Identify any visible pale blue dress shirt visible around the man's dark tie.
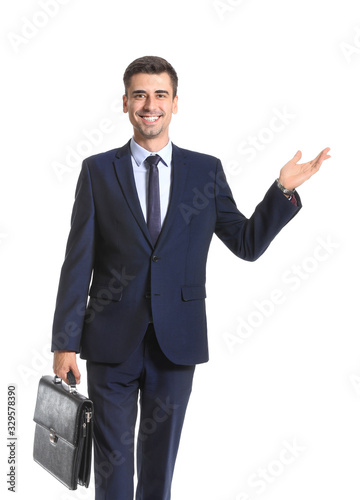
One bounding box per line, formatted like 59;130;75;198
130;137;172;229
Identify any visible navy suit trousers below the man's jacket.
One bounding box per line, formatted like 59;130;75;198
87;324;195;500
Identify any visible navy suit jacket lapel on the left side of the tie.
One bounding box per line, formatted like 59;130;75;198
114;141;152;246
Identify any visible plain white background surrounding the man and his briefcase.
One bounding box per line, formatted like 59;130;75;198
0;0;360;500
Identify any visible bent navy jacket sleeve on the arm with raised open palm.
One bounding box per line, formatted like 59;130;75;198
215;160;302;261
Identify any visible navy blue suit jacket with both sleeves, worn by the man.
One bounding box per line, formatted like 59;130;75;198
52;143;301;365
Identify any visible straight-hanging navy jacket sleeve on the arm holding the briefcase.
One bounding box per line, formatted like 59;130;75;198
51;160;95;352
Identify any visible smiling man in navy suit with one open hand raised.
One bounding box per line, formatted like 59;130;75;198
52;57;330;500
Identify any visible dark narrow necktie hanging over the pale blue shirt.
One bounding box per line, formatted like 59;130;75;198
146;155;161;246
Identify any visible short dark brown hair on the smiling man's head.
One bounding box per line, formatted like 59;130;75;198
124;56;178;97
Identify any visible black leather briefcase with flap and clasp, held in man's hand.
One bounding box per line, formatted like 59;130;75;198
33;372;94;490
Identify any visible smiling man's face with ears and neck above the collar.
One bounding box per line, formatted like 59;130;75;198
123;73;178;147
